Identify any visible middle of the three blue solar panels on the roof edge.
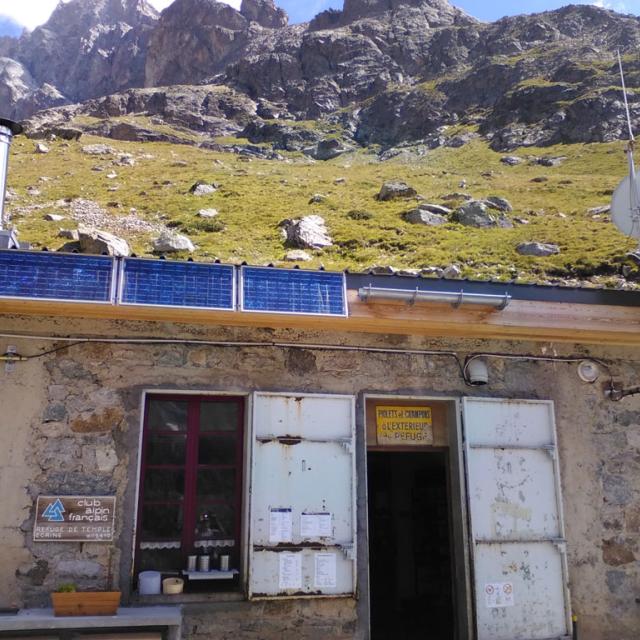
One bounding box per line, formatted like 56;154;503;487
118;258;235;311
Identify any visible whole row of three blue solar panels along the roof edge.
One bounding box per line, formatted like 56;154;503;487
0;250;347;316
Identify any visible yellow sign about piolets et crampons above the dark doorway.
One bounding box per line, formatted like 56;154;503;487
376;406;433;446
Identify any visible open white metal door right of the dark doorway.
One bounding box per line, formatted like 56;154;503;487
463;398;571;640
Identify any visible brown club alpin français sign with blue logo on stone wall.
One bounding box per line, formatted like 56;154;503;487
33;496;116;542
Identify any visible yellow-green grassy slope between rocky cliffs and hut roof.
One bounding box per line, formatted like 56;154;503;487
9;122;635;285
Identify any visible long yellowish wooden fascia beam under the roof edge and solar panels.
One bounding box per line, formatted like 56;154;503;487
0;291;640;346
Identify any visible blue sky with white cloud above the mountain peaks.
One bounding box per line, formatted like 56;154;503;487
0;0;640;29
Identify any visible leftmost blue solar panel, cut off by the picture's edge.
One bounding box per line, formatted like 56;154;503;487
0;249;114;303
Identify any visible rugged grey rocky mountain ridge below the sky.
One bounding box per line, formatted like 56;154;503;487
0;0;640;155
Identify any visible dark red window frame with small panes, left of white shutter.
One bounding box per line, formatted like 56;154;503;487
134;394;245;576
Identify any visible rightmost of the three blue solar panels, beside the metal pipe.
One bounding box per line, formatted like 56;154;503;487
241;267;347;316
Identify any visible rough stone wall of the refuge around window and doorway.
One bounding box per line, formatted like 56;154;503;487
0;317;640;640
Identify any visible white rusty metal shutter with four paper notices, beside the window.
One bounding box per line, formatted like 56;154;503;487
249;393;356;598
